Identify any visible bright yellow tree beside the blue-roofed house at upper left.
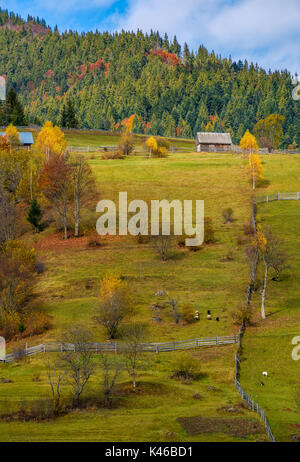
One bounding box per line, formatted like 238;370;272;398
34;121;67;159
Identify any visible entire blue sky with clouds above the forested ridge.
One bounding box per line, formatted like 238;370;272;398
0;0;300;75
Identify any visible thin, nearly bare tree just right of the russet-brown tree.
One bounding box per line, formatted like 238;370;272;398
70;157;95;237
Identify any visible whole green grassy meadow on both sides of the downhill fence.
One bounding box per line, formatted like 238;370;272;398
0;147;300;441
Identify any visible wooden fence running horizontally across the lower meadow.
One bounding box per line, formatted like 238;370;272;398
1;335;238;362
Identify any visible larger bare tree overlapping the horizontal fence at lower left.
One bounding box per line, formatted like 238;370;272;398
62;326;95;406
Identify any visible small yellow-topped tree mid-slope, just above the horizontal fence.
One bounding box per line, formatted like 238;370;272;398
95;275;133;339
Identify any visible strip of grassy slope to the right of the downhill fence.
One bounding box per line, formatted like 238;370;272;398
241;156;300;441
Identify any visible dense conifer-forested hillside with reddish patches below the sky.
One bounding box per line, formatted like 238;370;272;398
0;11;300;146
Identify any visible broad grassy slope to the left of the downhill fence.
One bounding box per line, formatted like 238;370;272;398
0;154;264;441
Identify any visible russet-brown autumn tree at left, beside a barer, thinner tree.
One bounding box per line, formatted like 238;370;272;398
40;154;72;239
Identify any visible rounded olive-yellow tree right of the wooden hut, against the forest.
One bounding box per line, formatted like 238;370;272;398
253;114;285;152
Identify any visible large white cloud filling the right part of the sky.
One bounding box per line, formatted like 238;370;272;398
112;0;300;72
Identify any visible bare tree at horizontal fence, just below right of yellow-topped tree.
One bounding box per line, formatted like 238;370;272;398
122;323;148;390
